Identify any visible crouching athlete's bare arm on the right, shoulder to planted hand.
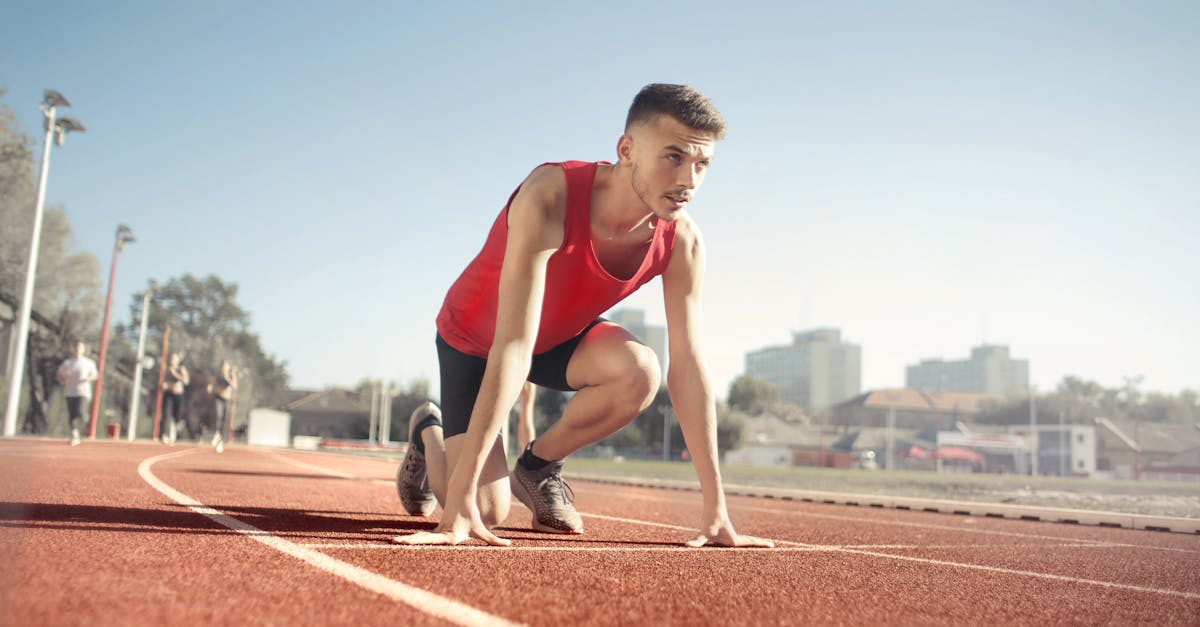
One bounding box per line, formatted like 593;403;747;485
662;215;774;547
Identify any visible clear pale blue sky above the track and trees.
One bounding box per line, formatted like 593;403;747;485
0;0;1200;396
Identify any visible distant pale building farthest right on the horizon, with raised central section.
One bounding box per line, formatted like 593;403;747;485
905;345;1030;394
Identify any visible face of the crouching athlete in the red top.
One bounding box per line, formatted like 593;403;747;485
617;115;716;221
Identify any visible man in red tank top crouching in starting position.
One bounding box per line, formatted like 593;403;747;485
395;84;772;547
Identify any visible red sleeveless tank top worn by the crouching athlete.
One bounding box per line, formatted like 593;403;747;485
438;161;674;357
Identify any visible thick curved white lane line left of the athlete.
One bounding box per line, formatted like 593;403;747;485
138;449;518;626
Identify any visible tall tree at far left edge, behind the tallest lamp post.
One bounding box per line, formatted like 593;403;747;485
0;89;101;434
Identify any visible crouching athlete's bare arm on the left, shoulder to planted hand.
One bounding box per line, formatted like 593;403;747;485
398;166;566;545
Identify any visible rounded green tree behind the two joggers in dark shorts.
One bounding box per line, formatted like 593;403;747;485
119;274;288;432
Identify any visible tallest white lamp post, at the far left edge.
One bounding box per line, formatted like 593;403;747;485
4;89;86;437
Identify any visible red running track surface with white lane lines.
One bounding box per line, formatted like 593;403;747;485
0;440;1200;626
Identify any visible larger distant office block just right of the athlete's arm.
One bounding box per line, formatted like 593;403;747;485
745;329;863;413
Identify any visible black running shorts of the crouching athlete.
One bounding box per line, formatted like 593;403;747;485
437;318;605;437
